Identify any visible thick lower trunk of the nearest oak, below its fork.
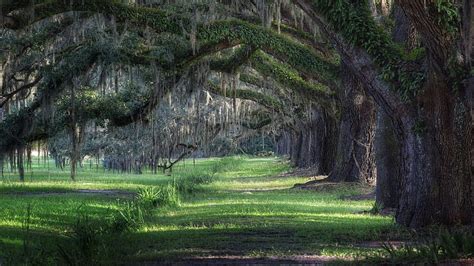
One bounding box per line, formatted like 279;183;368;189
396;75;473;228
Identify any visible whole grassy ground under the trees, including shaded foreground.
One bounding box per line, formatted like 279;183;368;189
0;157;466;265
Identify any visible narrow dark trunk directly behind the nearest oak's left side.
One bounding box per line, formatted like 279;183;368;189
375;108;402;208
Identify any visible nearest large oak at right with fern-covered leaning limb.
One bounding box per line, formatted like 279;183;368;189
297;0;473;227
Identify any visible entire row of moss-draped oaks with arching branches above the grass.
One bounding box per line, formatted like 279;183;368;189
0;0;474;233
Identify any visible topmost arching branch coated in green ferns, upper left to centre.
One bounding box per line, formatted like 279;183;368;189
10;0;338;86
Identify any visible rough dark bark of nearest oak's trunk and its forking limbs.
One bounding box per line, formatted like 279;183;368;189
295;0;473;228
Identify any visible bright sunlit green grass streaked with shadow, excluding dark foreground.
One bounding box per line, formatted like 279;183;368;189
0;158;400;260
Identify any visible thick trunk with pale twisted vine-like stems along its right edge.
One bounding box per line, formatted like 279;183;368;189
327;65;376;184
